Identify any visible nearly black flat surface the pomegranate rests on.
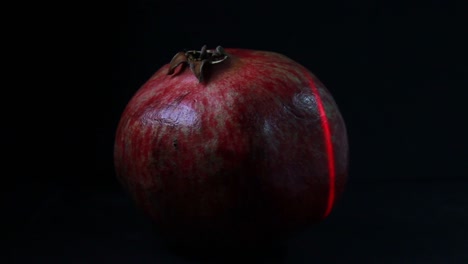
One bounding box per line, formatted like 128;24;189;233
7;178;468;264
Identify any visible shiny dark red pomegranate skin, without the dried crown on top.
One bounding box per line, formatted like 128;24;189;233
114;49;348;249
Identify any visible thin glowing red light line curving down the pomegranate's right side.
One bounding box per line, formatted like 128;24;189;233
307;74;335;218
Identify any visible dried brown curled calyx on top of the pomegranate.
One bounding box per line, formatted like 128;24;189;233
167;45;229;82
